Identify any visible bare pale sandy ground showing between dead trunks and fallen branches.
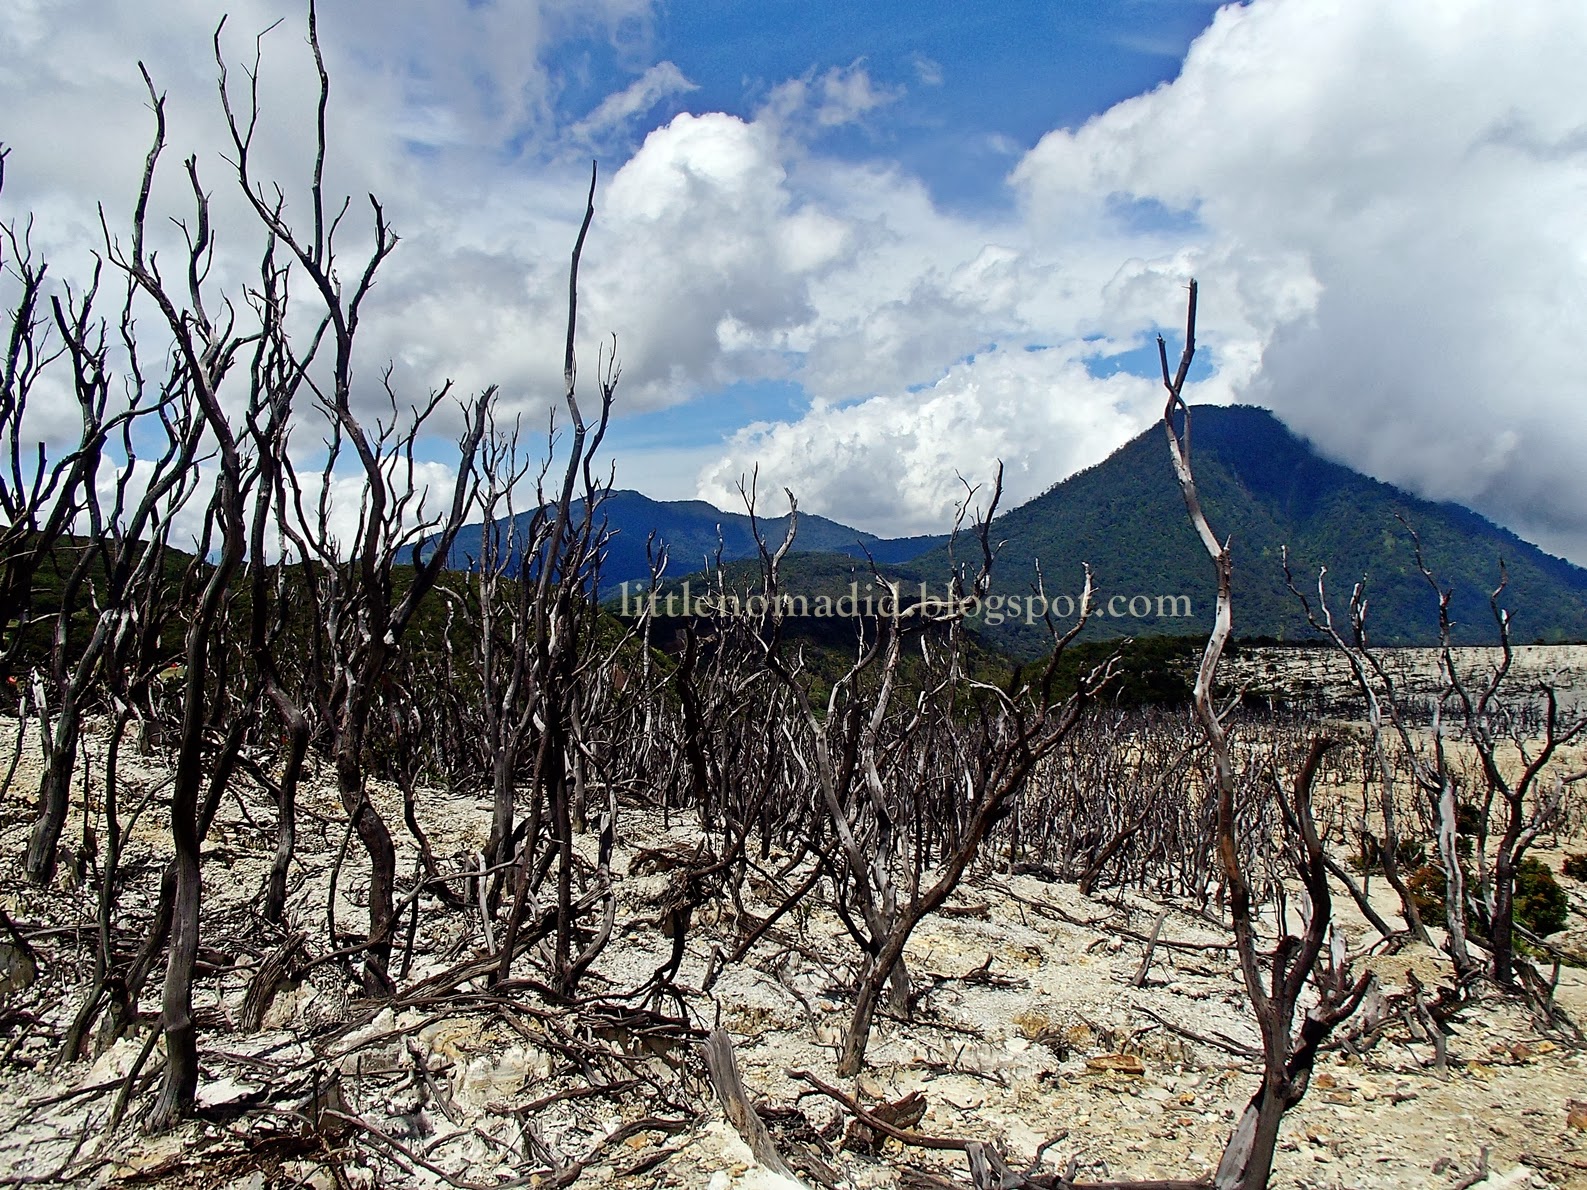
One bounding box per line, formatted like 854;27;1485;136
0;666;1587;1190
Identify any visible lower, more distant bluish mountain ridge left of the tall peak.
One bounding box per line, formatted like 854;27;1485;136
448;490;946;595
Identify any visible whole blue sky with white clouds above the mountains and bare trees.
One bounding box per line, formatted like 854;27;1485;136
0;0;1587;563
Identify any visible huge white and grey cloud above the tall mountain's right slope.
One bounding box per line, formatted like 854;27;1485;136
1014;0;1587;559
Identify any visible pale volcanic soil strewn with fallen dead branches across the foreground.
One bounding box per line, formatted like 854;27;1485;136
0;656;1587;1190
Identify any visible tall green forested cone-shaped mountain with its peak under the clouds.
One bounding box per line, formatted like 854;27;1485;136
908;406;1587;654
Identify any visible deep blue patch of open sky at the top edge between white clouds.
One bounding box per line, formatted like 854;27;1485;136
555;0;1216;209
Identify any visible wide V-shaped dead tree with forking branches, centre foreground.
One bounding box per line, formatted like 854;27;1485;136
746;468;1112;1076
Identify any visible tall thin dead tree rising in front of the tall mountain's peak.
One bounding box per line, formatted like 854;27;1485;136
1157;281;1370;1190
